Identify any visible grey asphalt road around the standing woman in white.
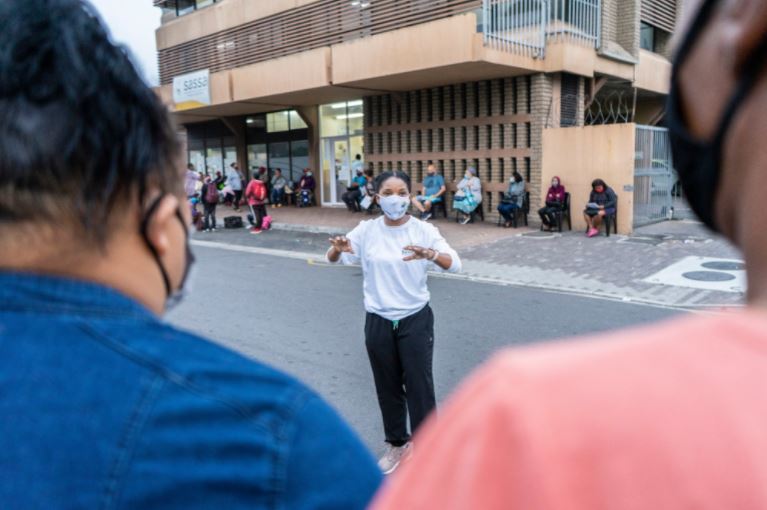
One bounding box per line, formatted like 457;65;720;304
169;243;678;453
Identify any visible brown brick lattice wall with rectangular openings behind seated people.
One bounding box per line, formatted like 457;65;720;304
365;74;551;219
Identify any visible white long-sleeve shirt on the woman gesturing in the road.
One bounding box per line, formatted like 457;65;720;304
326;216;461;321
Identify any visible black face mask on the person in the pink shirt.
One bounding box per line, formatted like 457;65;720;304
667;0;767;232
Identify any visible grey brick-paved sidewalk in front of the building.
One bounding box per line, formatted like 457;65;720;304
208;207;745;313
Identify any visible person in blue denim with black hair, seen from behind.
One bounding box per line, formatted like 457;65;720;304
0;0;382;510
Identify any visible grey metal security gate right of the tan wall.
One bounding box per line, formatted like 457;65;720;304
634;126;676;227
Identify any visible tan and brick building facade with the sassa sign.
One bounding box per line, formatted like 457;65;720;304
155;0;681;227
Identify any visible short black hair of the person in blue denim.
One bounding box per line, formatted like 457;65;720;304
0;0;181;245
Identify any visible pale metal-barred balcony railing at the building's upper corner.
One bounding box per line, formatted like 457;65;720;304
482;0;602;58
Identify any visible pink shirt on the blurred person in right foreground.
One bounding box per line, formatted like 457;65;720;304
373;311;767;510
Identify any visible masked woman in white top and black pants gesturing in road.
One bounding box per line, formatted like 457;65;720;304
327;172;461;474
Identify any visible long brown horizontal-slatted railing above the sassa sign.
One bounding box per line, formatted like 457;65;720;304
159;0;482;84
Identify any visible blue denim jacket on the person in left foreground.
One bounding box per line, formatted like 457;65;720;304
0;272;381;510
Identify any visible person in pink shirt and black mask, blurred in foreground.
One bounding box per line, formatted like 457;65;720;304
372;0;767;510
